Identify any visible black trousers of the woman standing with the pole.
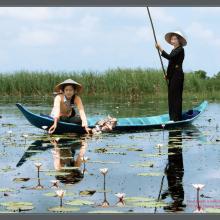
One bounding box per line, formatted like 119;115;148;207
168;72;184;121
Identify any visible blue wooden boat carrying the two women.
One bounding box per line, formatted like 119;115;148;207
16;101;208;134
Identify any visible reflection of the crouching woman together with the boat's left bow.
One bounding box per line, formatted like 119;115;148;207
16;136;87;185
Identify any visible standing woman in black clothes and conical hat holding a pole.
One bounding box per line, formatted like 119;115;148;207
156;31;187;121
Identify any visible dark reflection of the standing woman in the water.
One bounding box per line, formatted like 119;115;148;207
161;130;186;212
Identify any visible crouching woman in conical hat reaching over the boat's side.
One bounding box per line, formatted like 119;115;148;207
49;79;90;134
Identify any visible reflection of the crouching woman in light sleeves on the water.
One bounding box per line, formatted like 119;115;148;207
51;139;87;184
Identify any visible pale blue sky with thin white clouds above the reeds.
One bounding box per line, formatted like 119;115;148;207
0;7;220;76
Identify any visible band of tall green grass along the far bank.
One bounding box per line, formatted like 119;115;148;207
0;68;220;99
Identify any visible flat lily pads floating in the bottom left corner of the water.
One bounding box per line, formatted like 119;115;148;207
0;202;34;212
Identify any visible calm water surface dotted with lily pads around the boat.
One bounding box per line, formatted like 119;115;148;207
0;98;220;213
